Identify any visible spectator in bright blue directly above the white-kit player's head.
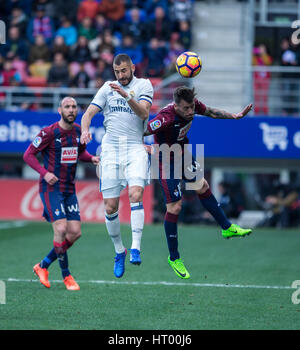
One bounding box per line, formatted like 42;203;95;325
115;35;144;77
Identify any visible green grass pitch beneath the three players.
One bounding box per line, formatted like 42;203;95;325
0;222;300;330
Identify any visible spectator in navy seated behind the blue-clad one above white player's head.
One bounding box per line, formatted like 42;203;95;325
121;7;147;44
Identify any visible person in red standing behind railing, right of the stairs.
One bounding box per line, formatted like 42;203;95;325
252;44;273;115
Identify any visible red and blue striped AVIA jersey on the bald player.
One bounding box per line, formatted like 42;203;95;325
24;122;86;193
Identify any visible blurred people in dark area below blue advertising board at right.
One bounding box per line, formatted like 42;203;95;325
153;171;300;229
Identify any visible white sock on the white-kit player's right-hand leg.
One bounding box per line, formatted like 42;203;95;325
130;202;145;251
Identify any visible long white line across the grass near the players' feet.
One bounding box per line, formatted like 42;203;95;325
0;278;295;289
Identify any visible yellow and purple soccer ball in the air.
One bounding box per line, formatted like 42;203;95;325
176;51;202;78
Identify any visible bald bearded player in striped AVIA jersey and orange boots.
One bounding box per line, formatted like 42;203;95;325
23;97;99;290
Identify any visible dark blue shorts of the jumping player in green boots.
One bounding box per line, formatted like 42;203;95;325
159;157;200;203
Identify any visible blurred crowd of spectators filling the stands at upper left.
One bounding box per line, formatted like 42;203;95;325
0;0;193;88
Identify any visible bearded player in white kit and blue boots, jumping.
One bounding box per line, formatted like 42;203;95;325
81;54;153;278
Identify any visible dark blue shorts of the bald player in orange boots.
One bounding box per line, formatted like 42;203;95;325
40;191;80;222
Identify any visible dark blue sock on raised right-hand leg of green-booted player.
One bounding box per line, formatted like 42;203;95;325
198;189;231;230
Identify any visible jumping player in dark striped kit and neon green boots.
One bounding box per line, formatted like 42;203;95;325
145;86;252;279
